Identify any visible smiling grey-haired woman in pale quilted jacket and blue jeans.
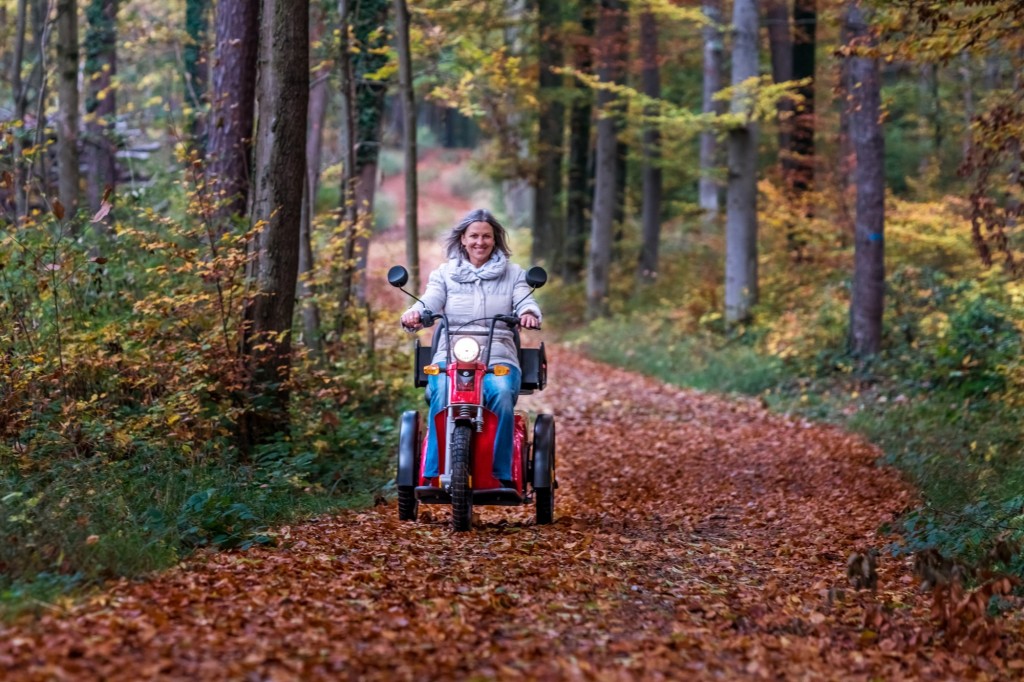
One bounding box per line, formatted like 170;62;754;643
401;209;541;487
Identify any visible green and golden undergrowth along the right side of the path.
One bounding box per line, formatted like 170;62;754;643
561;184;1024;578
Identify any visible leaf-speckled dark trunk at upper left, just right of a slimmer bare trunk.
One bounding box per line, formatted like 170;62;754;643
84;0;118;216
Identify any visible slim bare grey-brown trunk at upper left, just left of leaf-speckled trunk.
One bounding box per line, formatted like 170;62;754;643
56;0;80;219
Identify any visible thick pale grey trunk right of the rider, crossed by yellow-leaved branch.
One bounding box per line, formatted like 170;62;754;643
725;0;758;325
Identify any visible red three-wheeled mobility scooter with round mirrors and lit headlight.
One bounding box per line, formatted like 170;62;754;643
387;265;558;531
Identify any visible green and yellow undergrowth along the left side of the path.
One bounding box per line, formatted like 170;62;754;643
0;160;414;616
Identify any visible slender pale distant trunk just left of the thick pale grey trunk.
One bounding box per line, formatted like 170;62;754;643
697;0;724;231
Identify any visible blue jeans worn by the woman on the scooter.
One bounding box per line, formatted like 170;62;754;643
423;363;522;480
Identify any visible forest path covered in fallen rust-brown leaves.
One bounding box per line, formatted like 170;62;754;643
0;151;1024;680
